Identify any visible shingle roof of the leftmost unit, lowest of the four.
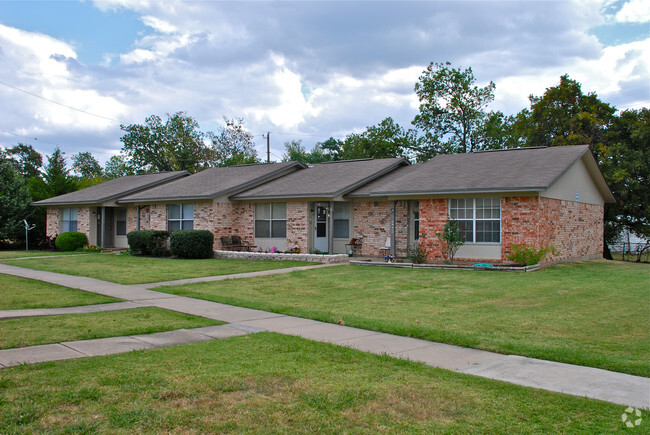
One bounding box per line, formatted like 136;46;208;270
32;171;190;205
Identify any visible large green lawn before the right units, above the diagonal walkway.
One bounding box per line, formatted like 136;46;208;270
158;261;650;377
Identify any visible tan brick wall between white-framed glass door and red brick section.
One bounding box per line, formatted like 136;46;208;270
352;201;408;257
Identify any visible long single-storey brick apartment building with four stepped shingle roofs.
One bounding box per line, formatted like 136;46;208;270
34;145;614;263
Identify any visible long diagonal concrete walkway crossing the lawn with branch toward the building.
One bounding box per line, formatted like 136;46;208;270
0;264;650;409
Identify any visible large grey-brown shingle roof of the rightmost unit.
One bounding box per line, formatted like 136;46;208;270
349;145;608;197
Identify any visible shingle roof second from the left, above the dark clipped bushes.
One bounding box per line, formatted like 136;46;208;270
118;162;305;204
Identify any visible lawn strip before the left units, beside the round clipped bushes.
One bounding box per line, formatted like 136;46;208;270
3;254;313;284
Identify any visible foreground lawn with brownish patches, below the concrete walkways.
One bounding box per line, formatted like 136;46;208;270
0;333;628;434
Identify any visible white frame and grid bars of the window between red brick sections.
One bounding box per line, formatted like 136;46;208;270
448;197;501;245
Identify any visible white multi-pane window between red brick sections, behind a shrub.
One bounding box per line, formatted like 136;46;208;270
449;198;501;243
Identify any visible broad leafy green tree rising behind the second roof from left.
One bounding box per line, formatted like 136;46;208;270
120;112;214;173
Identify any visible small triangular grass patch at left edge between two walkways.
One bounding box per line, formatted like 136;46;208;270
0;274;121;310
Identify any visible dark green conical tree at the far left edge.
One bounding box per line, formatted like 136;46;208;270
0;159;32;241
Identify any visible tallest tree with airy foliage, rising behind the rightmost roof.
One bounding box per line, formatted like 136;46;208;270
413;62;495;156
